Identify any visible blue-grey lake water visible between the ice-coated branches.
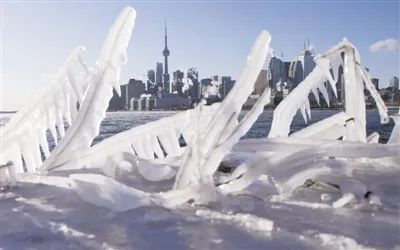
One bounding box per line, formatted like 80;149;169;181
0;110;394;143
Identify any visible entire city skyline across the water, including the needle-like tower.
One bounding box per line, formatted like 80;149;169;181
108;30;400;111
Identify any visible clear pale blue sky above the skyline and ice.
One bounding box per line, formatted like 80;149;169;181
0;0;400;110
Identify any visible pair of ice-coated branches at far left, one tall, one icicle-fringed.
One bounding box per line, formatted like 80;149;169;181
1;7;136;176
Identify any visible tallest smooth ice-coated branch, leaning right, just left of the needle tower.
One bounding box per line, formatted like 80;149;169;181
41;7;136;171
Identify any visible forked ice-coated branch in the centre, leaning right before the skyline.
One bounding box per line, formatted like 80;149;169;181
174;31;271;189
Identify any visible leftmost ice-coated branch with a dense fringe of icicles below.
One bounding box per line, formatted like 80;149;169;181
0;47;91;173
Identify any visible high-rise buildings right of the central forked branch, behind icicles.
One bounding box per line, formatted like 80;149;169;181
252;39;400;108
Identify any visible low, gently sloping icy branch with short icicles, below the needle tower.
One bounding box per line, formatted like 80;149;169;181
60;103;220;169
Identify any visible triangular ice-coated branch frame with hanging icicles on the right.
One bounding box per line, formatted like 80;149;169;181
268;39;389;142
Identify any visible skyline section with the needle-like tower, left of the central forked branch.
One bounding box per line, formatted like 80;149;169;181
108;23;235;111
